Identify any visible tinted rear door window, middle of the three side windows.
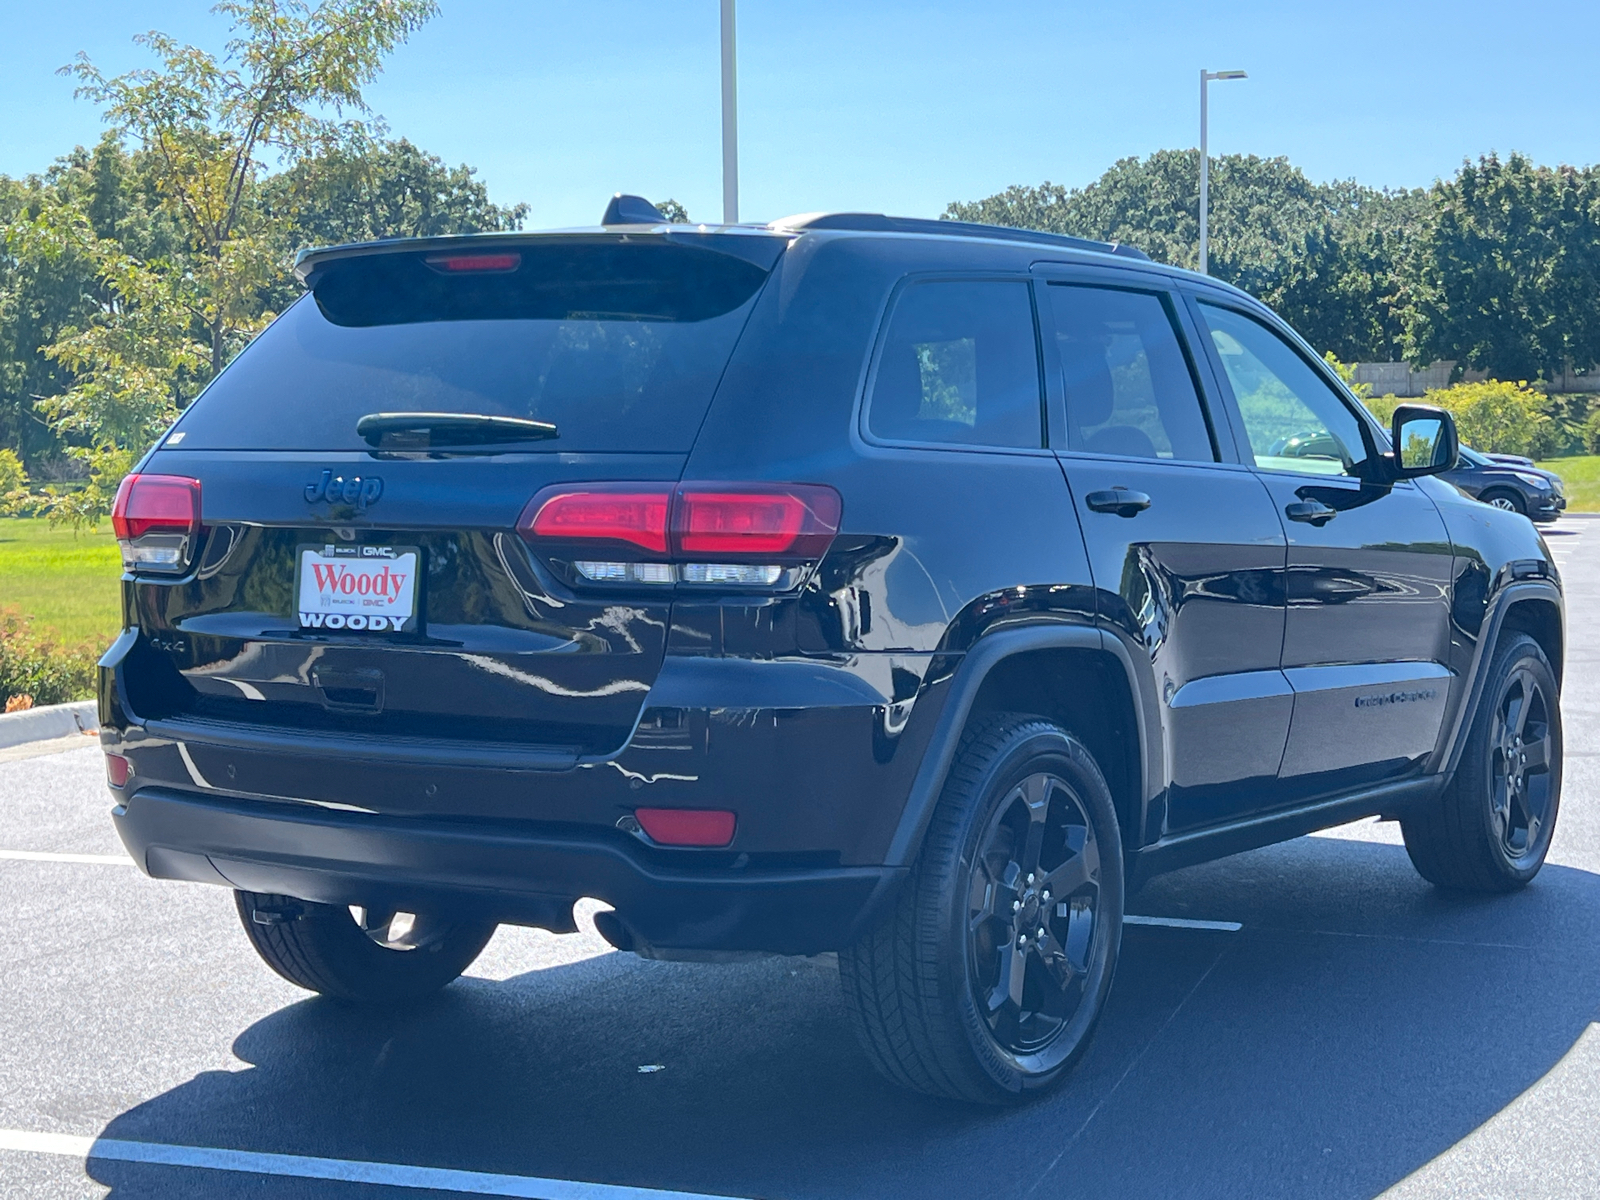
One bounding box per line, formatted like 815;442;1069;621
1048;283;1216;462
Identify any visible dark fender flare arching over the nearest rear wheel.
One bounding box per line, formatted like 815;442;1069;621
886;624;1162;867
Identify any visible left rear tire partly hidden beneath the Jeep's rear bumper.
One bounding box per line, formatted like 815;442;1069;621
234;891;494;1005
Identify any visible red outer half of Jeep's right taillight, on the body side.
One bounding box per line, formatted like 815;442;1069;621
672;485;840;560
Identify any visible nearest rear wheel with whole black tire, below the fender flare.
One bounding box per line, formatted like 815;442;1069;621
838;714;1123;1104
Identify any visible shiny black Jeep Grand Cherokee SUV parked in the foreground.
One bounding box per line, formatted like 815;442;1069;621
99;202;1563;1102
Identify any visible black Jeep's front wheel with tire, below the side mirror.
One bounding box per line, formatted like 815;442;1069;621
1400;634;1562;893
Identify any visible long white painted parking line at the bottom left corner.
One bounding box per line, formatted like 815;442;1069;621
0;1130;748;1200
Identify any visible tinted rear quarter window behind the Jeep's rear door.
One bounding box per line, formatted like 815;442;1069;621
867;280;1045;450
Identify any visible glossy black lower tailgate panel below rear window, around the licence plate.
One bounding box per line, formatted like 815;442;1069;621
120;451;683;754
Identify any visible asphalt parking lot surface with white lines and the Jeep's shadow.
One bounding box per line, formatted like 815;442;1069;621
0;518;1600;1200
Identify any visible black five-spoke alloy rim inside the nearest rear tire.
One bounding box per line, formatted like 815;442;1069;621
966;771;1104;1072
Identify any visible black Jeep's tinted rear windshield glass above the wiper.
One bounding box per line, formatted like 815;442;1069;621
178;243;766;453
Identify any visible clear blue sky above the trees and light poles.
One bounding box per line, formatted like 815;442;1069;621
0;0;1600;227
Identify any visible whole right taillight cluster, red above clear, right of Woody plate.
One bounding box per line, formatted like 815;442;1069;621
517;483;842;590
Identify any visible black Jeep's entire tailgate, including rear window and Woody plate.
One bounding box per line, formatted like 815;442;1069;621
114;235;784;763
